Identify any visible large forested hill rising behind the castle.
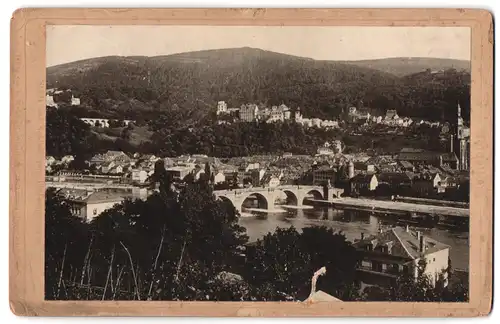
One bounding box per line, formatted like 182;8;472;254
47;48;470;122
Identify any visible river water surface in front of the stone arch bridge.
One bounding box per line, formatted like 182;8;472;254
239;207;469;269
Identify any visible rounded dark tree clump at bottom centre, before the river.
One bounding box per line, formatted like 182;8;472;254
244;227;358;300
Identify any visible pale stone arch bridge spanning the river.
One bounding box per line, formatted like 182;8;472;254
214;185;344;212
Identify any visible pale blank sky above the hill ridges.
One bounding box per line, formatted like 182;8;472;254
47;25;471;66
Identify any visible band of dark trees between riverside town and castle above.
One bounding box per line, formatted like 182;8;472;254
46;108;446;158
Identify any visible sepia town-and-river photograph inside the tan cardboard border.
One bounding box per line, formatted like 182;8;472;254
44;25;472;303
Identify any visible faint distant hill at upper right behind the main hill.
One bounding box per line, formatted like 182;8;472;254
341;57;470;76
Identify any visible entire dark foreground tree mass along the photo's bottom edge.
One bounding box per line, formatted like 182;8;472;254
45;174;467;301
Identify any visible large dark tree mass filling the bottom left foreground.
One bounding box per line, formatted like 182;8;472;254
46;173;248;300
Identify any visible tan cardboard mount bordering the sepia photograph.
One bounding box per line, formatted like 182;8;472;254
9;8;493;317
